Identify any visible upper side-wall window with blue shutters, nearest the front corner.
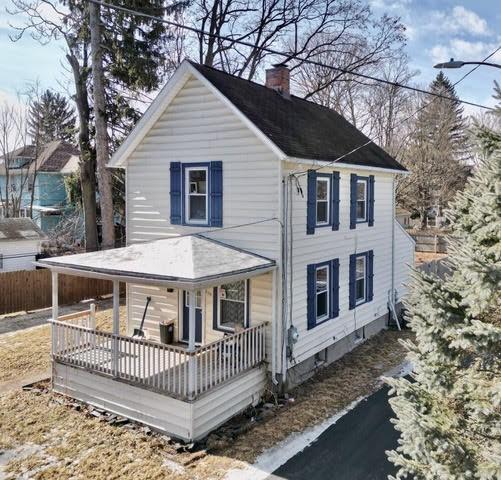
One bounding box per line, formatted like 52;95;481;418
306;170;339;235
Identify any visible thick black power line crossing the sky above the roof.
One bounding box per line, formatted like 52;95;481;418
86;0;494;110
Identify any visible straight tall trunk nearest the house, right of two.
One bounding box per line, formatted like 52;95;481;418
89;3;115;248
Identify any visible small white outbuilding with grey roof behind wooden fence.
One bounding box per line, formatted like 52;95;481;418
0;218;45;273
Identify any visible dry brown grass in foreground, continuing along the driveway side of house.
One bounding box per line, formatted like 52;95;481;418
0;331;409;480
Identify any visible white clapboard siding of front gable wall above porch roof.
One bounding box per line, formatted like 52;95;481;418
127;77;280;259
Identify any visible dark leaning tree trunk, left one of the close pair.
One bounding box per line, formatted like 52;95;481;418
66;54;98;252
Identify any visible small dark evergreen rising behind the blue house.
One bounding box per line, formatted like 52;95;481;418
28;89;76;146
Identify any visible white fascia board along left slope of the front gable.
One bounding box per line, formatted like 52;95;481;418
107;60;194;168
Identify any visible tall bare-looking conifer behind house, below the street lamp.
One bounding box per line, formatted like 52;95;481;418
398;72;470;227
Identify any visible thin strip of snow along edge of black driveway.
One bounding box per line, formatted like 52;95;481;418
224;361;412;480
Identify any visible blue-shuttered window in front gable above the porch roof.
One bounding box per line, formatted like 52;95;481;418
170;161;223;227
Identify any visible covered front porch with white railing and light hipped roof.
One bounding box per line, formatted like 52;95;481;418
39;235;276;440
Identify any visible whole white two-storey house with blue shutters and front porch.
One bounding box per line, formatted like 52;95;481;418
40;61;414;440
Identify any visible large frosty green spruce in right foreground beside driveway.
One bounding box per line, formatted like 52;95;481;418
388;84;501;480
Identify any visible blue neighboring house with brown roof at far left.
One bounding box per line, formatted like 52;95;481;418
0;140;79;232
